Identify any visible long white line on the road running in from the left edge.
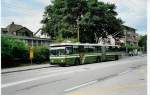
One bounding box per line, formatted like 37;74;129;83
1;69;85;88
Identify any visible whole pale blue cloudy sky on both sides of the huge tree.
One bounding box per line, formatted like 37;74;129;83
1;0;147;34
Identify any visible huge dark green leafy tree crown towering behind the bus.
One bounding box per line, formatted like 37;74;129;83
42;0;123;43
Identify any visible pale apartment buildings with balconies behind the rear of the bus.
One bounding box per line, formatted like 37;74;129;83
98;25;139;46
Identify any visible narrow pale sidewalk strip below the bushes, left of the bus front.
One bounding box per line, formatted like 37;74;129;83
1;63;52;74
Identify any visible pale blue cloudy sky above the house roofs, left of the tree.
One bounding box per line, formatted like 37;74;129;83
1;0;48;32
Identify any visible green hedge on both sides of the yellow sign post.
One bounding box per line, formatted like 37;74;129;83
1;37;49;68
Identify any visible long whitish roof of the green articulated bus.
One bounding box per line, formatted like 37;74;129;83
49;43;118;47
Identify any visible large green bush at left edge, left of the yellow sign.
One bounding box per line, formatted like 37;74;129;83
1;37;28;68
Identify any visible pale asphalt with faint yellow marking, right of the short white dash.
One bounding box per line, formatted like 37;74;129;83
65;65;147;95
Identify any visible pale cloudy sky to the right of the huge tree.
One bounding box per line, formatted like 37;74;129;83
100;0;147;33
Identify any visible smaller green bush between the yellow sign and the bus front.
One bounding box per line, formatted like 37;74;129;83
33;46;49;63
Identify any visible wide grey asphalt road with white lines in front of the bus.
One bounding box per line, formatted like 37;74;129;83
1;56;147;95
